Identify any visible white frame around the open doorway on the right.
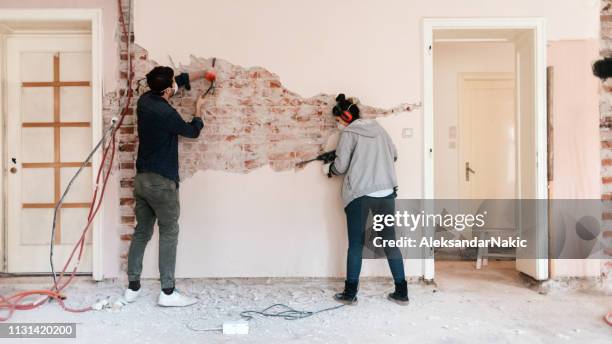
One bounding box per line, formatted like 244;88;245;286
423;18;548;280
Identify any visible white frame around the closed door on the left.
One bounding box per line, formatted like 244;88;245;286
0;8;104;280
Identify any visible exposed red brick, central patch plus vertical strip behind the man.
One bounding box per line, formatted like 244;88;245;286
103;42;421;255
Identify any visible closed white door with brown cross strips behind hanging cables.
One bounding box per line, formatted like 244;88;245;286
6;35;93;273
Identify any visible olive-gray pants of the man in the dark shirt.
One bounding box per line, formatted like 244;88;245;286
128;173;180;289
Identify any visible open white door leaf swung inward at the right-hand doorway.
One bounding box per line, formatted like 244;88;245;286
515;30;548;280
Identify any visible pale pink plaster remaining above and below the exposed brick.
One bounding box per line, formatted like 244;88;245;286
126;0;599;276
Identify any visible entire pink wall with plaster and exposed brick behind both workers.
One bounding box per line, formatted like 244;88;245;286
0;0;600;277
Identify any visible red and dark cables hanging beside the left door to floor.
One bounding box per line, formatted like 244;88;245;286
0;0;134;321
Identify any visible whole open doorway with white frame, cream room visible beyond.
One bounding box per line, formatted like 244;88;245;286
424;18;548;280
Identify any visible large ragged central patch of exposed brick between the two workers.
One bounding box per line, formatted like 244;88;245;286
136;56;419;179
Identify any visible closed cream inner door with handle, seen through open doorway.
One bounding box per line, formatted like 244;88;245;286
459;73;516;199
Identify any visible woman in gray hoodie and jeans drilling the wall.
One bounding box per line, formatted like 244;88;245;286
323;94;408;304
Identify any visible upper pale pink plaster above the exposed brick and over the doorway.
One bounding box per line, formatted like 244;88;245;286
135;0;599;106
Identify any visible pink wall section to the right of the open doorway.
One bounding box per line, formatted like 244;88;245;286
548;40;603;277
